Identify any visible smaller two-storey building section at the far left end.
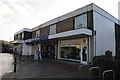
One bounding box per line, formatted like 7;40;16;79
11;28;32;55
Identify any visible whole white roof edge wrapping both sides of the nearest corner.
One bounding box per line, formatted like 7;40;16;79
28;3;120;31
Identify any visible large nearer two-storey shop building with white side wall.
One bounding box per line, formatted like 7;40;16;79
12;3;120;64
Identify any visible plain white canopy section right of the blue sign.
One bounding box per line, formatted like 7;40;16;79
48;28;92;39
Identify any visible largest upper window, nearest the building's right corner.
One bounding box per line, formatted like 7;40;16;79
75;13;87;29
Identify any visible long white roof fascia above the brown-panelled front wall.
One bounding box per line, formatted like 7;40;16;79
32;4;92;31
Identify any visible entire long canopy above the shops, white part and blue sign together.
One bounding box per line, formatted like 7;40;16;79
15;28;92;43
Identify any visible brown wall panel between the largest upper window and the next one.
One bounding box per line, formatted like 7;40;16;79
56;18;74;33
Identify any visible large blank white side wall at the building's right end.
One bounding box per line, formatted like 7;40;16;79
93;11;115;56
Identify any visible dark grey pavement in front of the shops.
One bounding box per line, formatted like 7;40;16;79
3;56;97;80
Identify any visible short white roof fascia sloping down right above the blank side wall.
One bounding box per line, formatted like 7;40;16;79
93;4;119;24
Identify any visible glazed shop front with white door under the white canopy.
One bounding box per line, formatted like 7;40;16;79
58;38;89;64
